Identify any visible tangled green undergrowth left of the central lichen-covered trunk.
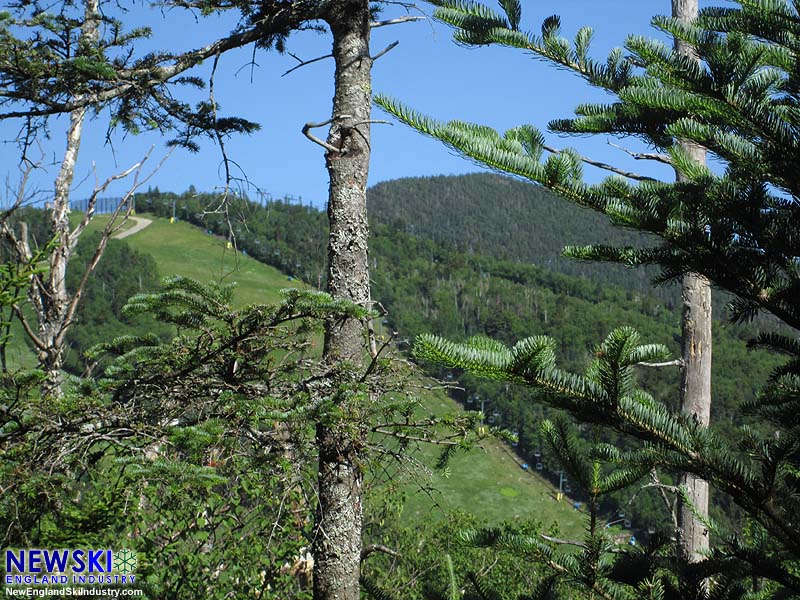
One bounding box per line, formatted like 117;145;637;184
0;277;366;599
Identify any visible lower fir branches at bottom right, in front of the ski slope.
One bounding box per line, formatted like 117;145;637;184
415;329;799;598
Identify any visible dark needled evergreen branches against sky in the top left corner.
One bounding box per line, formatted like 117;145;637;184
0;2;262;153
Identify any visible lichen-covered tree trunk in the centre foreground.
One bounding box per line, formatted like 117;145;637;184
313;0;372;600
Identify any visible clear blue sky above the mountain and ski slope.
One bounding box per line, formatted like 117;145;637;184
0;0;720;206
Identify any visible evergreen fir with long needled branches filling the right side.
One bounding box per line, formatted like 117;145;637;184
379;0;800;596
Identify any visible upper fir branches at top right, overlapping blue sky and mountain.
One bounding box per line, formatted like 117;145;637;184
377;2;800;327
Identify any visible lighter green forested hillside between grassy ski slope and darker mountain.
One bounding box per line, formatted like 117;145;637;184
137;184;776;527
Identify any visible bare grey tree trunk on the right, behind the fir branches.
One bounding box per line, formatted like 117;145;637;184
672;0;711;561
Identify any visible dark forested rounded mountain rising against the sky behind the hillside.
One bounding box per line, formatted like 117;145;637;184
367;173;678;306
